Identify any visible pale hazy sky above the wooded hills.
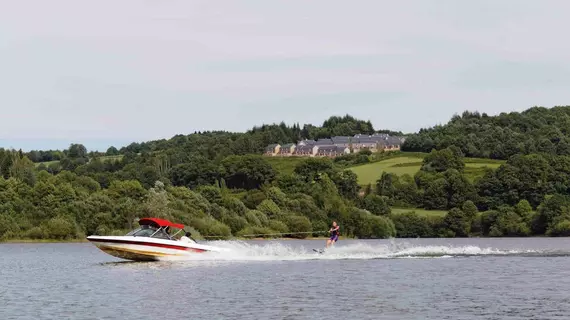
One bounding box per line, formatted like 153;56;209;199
0;0;570;151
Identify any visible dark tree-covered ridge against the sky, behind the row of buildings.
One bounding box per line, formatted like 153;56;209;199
24;115;403;163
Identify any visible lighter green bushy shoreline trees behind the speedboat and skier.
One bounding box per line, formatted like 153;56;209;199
0;151;396;239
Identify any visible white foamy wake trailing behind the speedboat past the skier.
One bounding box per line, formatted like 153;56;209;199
153;241;560;261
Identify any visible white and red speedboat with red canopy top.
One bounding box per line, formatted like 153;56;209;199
87;218;228;261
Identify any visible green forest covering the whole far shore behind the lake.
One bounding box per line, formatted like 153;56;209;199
0;107;570;241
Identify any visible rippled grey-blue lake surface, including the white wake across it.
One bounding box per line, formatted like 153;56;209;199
0;238;570;320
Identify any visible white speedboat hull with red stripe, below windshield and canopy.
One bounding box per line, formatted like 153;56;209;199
87;236;228;261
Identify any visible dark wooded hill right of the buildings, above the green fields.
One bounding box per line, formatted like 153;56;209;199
402;106;570;159
